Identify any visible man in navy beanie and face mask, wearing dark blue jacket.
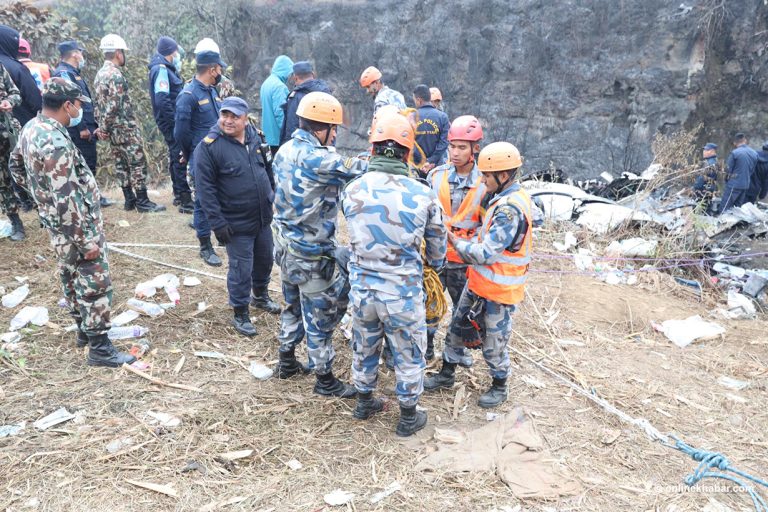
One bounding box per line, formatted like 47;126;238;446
149;36;195;214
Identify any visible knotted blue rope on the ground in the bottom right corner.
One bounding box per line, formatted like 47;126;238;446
668;436;768;512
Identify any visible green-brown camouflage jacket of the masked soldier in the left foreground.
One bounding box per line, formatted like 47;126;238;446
10;114;104;254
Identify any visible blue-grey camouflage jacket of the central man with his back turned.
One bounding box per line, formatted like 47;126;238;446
341;156;446;297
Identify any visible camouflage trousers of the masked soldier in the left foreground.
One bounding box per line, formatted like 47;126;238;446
54;244;112;336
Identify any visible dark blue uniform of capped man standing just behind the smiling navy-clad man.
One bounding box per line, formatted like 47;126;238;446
173;78;221;238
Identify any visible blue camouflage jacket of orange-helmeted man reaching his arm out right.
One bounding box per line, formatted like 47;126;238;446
272;129;368;259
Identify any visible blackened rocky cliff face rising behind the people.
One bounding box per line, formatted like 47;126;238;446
218;0;768;177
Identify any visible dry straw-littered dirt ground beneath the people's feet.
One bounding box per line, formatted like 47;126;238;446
0;191;768;512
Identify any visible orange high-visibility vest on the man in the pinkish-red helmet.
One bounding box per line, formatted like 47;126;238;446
432;169;485;263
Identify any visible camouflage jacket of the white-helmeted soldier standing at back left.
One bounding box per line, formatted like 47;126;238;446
93;61;138;137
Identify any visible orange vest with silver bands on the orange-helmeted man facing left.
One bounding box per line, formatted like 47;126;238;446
467;189;532;304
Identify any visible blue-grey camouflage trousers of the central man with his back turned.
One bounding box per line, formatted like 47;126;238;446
351;290;427;406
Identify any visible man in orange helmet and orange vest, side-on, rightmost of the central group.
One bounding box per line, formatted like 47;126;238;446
424;142;533;407
